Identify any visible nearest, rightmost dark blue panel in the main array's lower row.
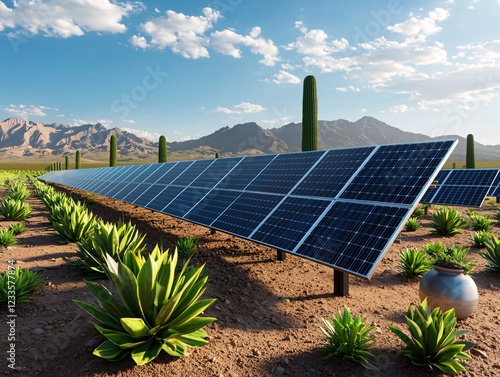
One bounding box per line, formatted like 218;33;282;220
296;202;408;276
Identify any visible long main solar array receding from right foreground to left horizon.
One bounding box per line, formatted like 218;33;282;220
40;140;457;278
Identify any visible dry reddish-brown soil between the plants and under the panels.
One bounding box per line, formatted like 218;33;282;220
0;187;500;377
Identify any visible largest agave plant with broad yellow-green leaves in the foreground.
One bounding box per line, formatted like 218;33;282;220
75;247;215;365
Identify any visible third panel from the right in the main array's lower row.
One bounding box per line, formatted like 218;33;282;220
211;192;283;237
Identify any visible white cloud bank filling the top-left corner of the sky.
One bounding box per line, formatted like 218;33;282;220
0;0;144;38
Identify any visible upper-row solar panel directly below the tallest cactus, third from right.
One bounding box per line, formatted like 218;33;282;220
245;151;325;194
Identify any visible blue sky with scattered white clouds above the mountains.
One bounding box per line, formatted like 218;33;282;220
0;0;500;144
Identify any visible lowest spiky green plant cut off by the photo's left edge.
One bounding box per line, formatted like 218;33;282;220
0;268;43;306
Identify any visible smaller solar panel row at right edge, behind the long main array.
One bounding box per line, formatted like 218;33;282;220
422;169;498;207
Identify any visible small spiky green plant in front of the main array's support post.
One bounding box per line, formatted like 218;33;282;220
320;307;377;370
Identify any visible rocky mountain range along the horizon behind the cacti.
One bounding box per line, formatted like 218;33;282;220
0;117;500;162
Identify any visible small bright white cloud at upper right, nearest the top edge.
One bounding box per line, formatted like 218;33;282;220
387;8;450;37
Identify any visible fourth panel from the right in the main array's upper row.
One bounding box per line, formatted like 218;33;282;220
216;155;276;191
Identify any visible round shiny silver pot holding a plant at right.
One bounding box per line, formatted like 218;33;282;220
419;266;479;319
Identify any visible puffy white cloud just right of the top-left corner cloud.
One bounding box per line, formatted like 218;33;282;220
130;7;221;59
